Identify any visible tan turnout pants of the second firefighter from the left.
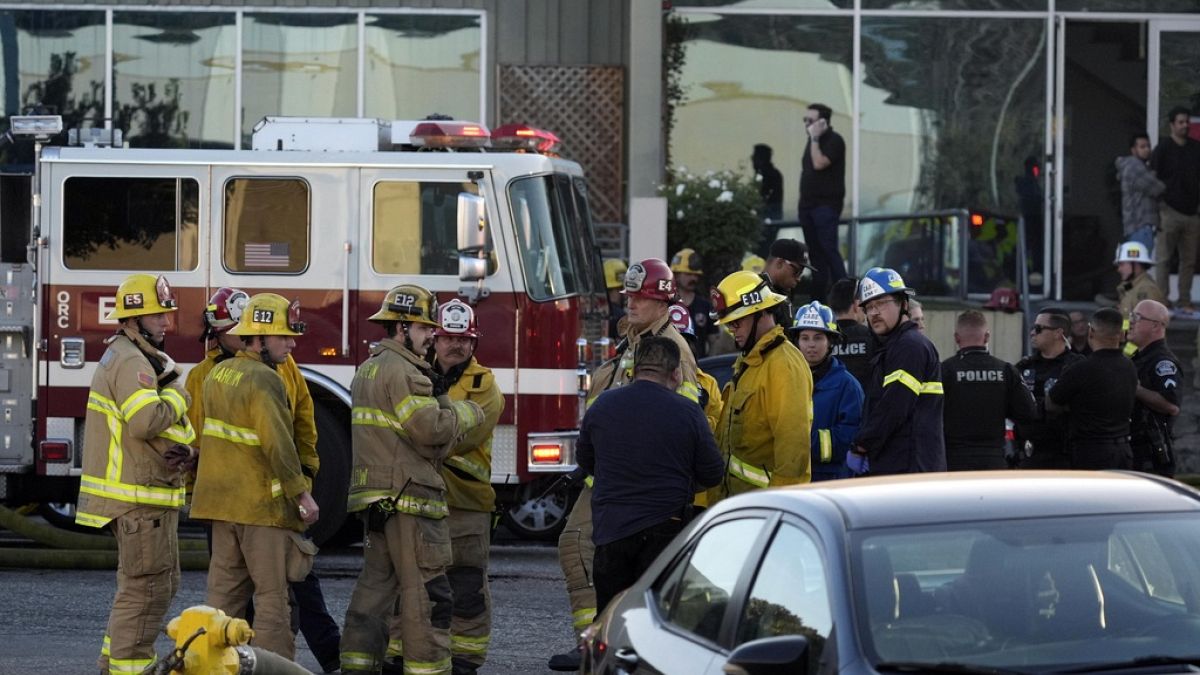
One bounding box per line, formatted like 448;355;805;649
208;520;296;658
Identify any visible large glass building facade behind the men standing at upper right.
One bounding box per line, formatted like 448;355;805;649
667;0;1200;299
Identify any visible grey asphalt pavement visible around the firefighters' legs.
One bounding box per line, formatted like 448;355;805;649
0;535;574;675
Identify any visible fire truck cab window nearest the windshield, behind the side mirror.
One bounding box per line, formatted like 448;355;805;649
371;180;482;276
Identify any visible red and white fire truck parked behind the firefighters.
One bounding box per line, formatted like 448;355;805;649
0;118;607;540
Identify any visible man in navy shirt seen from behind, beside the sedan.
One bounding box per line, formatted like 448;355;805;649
576;336;725;614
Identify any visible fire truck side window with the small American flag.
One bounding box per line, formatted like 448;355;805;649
224;178;311;274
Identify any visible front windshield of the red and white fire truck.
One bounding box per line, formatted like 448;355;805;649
509;174;604;300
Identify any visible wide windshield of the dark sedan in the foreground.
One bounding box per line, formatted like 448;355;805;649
852;514;1200;670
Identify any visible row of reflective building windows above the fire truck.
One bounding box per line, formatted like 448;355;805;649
0;5;487;154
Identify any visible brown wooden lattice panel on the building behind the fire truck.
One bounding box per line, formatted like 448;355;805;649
499;66;625;222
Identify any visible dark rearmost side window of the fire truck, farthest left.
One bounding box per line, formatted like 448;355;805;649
62;177;200;271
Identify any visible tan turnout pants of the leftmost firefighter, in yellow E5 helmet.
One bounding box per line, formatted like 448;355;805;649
98;506;179;675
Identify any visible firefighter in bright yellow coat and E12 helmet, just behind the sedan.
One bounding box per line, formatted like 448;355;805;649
713;271;812;497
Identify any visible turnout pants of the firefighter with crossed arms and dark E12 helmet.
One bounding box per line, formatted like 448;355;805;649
342;513;451;675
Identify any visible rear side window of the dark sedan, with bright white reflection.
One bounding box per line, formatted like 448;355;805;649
654;518;763;643
